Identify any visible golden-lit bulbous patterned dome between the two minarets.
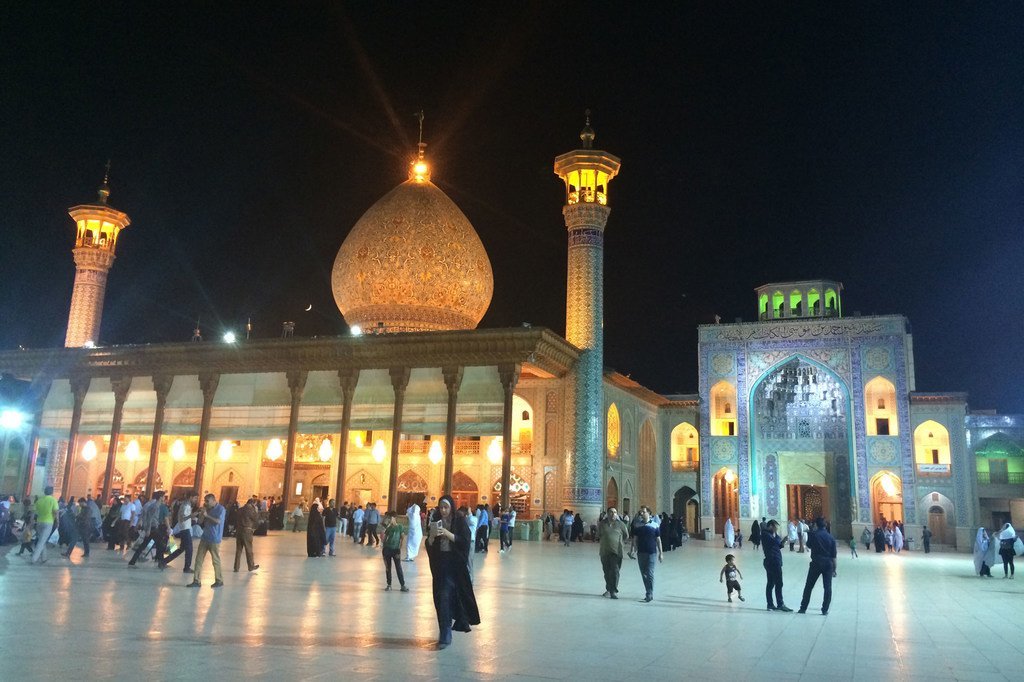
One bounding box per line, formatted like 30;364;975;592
331;169;495;332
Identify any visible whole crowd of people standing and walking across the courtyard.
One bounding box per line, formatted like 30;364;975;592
8;487;1024;648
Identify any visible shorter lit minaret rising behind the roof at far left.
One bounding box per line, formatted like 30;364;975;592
65;162;131;348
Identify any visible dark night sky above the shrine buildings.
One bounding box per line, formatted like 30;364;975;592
0;2;1024;413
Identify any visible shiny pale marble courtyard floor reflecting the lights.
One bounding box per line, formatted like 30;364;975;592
0;532;1024;681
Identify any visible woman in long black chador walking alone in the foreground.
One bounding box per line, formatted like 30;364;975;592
427;495;480;649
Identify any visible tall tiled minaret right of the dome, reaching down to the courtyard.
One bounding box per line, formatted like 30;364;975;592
555;110;618;519
